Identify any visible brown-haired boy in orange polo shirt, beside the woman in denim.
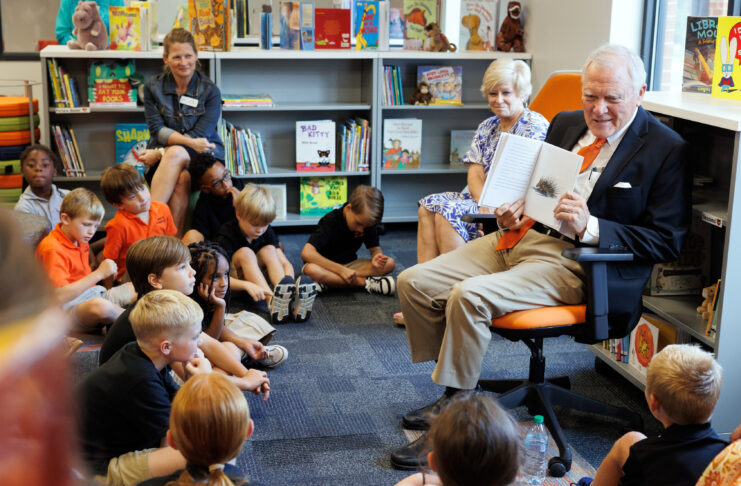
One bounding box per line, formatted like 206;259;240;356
100;164;178;280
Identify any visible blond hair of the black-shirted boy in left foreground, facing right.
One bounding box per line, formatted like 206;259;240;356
129;290;203;344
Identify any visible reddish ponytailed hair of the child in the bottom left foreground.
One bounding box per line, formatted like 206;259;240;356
170;373;250;485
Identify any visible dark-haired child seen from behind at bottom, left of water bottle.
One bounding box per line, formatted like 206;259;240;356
396;393;522;486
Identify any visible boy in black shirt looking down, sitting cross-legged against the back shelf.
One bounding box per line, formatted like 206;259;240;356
301;185;396;295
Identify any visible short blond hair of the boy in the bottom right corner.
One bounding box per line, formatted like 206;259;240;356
646;344;722;425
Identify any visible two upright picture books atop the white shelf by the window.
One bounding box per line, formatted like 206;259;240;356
682;17;741;99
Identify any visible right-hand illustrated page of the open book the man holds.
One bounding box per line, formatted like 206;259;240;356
525;143;584;238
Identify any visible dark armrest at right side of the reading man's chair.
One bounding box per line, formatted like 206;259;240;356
561;247;633;342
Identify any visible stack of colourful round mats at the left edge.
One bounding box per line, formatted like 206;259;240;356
0;96;41;208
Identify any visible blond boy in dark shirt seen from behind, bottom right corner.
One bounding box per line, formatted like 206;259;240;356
578;344;728;486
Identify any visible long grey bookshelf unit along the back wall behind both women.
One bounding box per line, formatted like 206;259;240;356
41;46;531;226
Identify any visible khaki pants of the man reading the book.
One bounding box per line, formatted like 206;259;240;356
397;230;584;389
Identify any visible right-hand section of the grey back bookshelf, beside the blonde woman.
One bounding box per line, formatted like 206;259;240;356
374;50;532;222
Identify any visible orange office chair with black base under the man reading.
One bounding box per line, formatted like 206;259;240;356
462;214;643;477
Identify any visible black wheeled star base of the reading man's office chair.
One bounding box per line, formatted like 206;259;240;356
479;376;643;477
